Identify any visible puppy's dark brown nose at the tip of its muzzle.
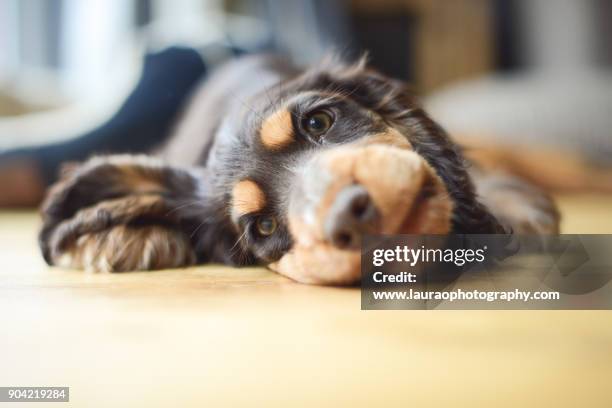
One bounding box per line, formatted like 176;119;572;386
323;185;379;249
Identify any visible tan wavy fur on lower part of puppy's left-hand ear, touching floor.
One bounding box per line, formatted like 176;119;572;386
49;194;195;272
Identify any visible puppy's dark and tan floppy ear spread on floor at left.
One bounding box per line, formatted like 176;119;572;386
39;155;208;272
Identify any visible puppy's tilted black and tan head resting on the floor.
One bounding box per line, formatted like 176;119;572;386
200;57;503;283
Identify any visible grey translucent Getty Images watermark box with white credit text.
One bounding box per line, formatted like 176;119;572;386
361;235;612;309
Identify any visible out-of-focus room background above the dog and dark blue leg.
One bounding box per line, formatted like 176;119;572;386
0;0;612;174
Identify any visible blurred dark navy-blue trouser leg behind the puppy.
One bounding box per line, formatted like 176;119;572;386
0;47;215;185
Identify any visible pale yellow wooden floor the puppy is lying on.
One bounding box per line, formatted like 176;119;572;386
0;196;612;407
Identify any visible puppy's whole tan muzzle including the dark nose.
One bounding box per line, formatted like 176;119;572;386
271;144;452;284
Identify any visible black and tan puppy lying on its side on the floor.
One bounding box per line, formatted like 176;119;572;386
39;55;559;284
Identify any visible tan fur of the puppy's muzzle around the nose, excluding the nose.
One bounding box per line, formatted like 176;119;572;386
270;145;453;284
